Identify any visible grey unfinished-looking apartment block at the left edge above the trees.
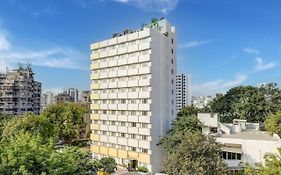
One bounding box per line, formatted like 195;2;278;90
0;65;41;115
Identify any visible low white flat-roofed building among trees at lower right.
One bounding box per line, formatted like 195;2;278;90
198;113;281;174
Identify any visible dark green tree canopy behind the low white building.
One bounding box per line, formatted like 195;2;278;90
211;83;281;122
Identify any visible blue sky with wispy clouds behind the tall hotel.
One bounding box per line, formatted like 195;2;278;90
0;0;281;95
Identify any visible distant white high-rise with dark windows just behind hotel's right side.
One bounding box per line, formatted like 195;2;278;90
176;74;191;112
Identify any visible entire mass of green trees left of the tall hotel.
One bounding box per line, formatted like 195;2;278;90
0;103;116;175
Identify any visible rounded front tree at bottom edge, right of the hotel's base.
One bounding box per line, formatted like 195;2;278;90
164;132;226;175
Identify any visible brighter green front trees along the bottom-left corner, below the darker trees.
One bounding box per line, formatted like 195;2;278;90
0;131;98;175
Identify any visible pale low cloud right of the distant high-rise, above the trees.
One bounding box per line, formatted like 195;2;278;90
192;74;248;96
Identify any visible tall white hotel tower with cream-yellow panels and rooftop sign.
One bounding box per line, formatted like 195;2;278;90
91;18;177;172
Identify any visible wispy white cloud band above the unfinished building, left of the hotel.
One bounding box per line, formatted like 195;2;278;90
0;30;88;72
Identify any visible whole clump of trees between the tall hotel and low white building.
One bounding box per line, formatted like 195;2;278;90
160;107;226;175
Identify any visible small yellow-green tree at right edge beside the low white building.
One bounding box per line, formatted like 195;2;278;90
265;112;281;137
